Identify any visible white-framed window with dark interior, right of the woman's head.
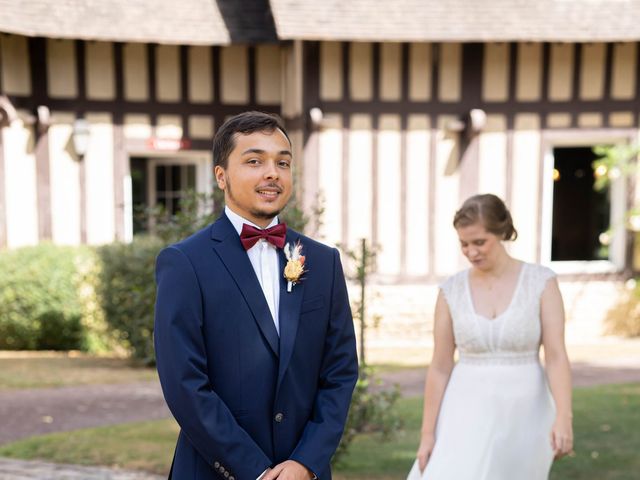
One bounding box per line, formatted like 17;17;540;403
540;139;627;273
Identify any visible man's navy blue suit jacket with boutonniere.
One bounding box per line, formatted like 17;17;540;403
154;215;358;480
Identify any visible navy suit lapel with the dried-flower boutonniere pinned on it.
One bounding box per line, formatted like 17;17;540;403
278;230;305;388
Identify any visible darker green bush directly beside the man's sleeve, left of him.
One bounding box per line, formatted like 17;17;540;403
97;236;165;364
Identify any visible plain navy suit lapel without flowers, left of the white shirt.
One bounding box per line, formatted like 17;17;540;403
211;215;282;356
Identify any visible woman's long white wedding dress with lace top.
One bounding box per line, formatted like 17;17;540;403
407;263;555;480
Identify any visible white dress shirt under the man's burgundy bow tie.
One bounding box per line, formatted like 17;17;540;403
224;206;280;335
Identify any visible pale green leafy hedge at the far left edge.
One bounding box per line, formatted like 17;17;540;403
0;244;91;350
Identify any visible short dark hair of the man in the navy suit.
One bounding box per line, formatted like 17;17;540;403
213;111;291;170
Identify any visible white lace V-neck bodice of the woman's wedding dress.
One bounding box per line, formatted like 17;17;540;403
440;263;555;363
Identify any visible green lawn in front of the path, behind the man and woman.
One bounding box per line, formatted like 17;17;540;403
0;384;640;480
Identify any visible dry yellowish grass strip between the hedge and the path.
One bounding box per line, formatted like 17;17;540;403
0;351;158;390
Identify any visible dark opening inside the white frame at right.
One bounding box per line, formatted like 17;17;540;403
551;147;611;260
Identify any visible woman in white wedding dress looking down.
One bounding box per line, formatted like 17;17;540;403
408;195;573;480
